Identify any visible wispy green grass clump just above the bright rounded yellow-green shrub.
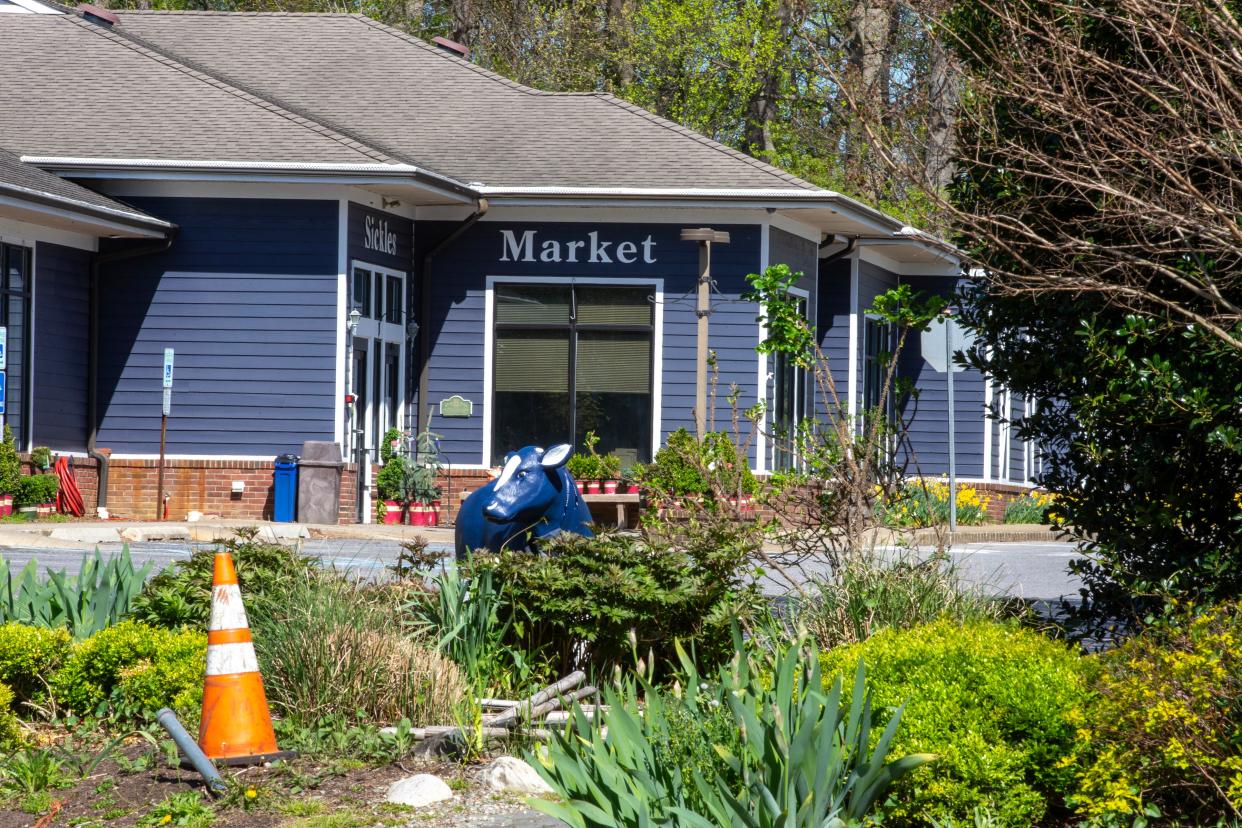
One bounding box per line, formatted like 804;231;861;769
799;552;1005;649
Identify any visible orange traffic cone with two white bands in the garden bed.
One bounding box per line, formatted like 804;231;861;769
199;551;292;765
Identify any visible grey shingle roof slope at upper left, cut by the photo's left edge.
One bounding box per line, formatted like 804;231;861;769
0;15;391;164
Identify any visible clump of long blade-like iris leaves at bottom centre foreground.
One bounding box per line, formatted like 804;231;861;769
527;629;932;828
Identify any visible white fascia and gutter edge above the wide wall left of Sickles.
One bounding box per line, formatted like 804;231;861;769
21;155;478;202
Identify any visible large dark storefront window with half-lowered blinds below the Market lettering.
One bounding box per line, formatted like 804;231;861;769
491;284;655;466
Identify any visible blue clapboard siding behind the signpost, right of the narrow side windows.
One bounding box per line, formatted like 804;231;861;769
898;276;985;478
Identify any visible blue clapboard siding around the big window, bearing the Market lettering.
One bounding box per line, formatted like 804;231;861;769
415;221;760;463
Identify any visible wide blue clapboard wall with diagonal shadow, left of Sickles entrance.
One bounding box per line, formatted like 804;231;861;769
98;199;338;456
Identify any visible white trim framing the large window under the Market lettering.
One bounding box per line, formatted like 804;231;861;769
481;276;664;468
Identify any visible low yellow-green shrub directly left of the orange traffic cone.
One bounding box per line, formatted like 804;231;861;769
51;621;207;716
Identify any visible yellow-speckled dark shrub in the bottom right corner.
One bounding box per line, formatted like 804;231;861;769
1072;602;1242;824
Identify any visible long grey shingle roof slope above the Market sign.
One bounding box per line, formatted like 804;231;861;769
114;11;817;190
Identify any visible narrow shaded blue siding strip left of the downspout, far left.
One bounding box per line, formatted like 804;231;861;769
34;242;91;451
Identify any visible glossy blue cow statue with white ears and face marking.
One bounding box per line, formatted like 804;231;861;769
456;443;591;560
